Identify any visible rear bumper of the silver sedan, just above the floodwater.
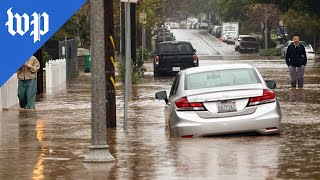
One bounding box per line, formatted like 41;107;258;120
170;103;281;137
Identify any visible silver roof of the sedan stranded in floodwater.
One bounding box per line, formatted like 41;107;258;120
180;63;254;75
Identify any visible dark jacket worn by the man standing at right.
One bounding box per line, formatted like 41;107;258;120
286;43;307;67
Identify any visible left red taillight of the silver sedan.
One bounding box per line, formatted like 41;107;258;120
175;97;206;111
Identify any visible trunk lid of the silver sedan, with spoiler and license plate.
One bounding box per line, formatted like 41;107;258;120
186;84;263;118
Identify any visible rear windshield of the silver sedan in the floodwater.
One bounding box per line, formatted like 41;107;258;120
185;68;260;90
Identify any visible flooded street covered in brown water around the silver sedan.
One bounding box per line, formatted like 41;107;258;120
0;30;320;180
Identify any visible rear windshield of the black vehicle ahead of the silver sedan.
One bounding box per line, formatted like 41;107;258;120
158;43;193;54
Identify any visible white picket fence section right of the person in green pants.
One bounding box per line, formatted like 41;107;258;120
45;59;67;92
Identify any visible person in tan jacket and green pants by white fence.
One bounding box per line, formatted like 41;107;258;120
17;56;40;109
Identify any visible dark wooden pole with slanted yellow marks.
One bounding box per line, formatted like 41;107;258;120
104;0;117;128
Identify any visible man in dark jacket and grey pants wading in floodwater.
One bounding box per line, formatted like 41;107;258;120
286;33;307;88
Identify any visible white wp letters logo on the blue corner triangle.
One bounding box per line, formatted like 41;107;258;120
6;8;49;43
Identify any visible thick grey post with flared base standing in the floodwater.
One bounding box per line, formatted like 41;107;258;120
83;0;115;163
